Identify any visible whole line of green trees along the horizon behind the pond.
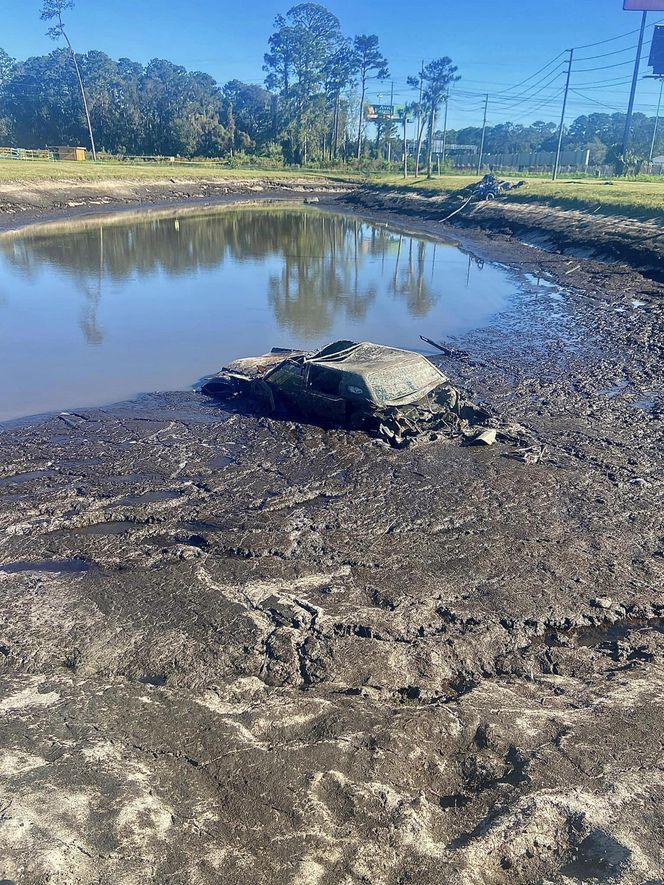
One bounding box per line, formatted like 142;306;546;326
0;0;664;167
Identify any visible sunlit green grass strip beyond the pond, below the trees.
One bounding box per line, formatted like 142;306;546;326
0;160;664;218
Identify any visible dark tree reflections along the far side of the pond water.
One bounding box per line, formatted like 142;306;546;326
0;206;446;345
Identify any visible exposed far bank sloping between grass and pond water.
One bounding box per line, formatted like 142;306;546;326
0;170;664;282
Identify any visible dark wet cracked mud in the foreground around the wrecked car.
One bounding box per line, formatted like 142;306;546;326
0;188;664;885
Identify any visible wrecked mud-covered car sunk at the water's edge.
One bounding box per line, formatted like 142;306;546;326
202;341;490;447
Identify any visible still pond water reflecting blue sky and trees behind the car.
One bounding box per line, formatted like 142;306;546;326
0;206;516;421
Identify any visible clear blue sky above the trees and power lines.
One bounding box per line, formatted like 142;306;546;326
0;0;664;128
